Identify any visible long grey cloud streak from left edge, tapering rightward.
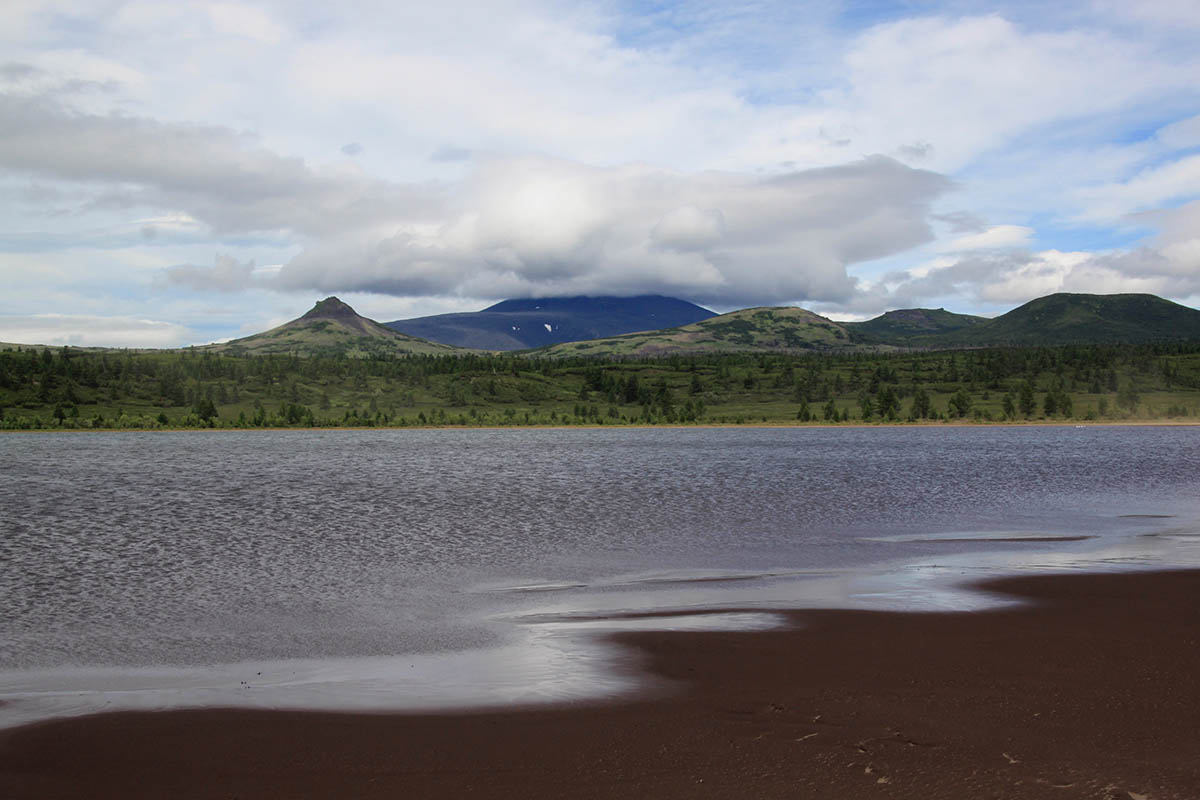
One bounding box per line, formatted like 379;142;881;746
0;95;437;235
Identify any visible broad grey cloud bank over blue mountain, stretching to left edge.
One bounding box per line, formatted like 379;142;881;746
0;89;952;305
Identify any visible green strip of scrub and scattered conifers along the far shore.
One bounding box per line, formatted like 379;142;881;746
0;342;1200;431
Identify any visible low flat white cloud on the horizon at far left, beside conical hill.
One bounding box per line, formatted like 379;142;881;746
0;314;192;348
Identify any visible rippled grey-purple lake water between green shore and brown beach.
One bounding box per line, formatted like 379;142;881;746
0;427;1200;726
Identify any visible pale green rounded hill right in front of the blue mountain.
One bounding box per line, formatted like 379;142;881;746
541;307;856;357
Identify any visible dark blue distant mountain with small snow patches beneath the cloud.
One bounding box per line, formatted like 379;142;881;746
385;295;715;350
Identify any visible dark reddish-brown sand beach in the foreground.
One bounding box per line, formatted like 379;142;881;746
0;571;1200;800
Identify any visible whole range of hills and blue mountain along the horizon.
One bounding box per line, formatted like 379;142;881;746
205;294;1200;357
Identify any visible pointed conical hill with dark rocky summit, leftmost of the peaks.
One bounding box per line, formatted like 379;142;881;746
203;297;460;356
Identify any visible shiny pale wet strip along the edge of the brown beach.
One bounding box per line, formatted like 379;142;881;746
0;513;1200;727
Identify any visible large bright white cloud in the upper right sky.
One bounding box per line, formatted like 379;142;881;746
824;13;1200;170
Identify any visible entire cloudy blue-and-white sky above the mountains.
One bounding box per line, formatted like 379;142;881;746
0;0;1200;347
